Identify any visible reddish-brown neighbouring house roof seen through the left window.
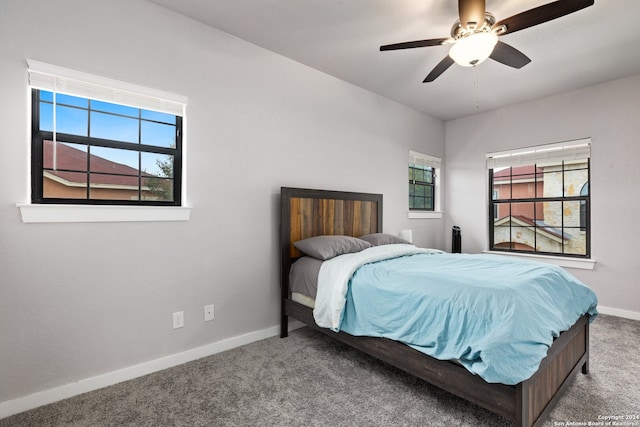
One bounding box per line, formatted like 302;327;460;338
43;141;154;188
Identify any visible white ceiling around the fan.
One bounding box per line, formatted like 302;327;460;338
149;0;640;121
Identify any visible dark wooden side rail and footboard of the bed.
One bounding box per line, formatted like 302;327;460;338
282;299;589;427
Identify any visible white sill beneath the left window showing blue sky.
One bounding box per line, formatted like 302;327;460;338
16;203;191;223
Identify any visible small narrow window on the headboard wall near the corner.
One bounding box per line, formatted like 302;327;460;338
409;151;440;212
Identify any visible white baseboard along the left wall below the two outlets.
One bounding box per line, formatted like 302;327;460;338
0;320;304;419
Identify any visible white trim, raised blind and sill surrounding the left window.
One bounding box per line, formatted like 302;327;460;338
16;59;191;223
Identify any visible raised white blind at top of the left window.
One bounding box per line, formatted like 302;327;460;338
27;59;187;117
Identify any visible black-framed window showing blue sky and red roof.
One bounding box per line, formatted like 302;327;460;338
30;61;183;206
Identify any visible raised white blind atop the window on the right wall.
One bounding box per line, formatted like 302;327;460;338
486;138;591;169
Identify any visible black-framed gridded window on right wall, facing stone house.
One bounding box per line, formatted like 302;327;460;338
487;140;591;258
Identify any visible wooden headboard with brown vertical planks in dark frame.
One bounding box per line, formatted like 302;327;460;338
280;187;382;298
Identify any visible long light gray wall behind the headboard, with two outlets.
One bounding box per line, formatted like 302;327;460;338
0;0;445;403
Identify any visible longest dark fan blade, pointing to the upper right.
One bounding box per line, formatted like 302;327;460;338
496;0;594;34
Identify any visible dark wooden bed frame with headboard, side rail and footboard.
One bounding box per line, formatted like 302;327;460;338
280;187;589;427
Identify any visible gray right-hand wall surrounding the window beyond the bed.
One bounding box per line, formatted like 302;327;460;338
446;75;640;316
